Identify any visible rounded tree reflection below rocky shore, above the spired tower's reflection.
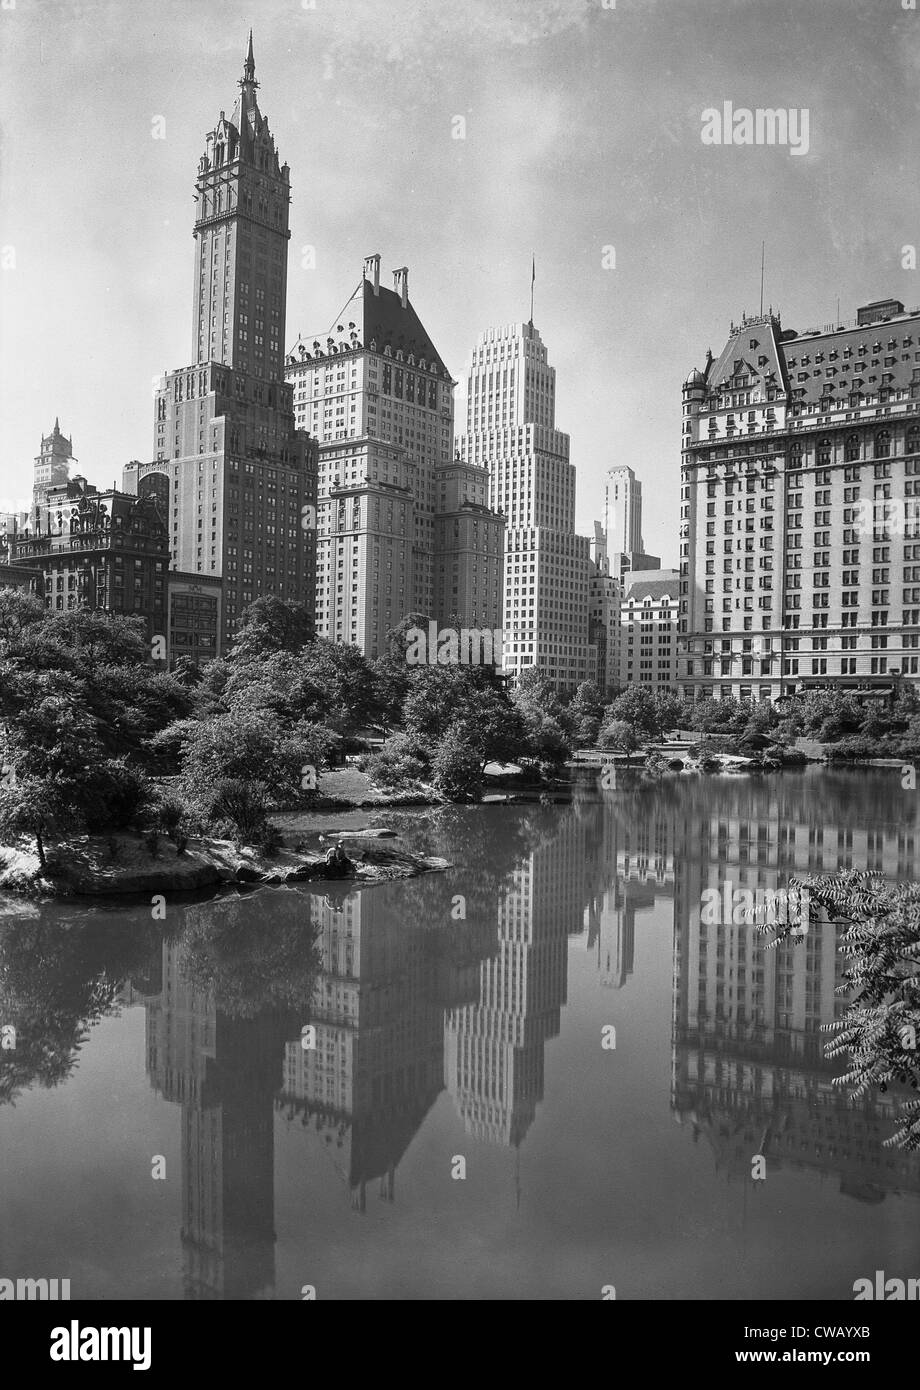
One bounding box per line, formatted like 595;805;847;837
179;888;320;1019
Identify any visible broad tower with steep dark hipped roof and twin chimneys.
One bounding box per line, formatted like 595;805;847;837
286;254;504;656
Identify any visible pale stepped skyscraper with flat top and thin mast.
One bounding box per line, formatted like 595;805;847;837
459;322;596;691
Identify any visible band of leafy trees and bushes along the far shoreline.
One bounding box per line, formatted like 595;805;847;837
0;589;920;884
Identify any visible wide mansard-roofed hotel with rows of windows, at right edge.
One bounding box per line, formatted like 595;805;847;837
678;299;920;699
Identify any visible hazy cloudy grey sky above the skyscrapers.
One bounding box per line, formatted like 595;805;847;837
0;0;920;564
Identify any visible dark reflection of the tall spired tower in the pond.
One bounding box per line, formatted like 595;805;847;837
143;941;289;1298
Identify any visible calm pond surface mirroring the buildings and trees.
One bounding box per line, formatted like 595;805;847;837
0;770;920;1300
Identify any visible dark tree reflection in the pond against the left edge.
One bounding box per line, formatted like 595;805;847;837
0;910;160;1104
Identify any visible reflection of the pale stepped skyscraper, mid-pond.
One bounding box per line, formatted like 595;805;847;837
445;809;585;1148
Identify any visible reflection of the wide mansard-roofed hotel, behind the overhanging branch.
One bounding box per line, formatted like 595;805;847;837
671;777;920;1202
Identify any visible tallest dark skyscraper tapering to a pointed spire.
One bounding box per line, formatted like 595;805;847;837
125;33;317;651
